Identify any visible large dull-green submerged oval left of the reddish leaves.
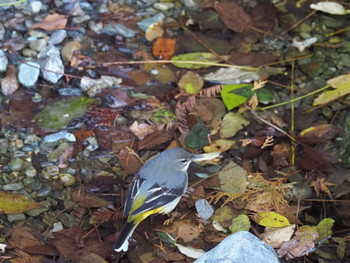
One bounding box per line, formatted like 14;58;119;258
34;97;96;129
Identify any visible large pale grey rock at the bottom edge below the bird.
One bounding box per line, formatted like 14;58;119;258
195;231;279;263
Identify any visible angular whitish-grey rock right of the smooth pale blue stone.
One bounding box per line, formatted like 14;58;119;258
38;44;64;84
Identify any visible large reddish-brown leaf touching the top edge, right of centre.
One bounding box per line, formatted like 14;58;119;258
214;1;253;33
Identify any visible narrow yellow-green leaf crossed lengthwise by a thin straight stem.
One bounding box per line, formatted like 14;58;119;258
171;52;219;69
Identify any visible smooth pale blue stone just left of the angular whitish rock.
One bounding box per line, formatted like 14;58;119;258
18;62;40;88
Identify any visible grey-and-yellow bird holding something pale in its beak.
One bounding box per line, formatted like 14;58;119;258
113;148;219;252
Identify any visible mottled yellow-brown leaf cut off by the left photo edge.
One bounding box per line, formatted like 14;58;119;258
0;191;43;215
